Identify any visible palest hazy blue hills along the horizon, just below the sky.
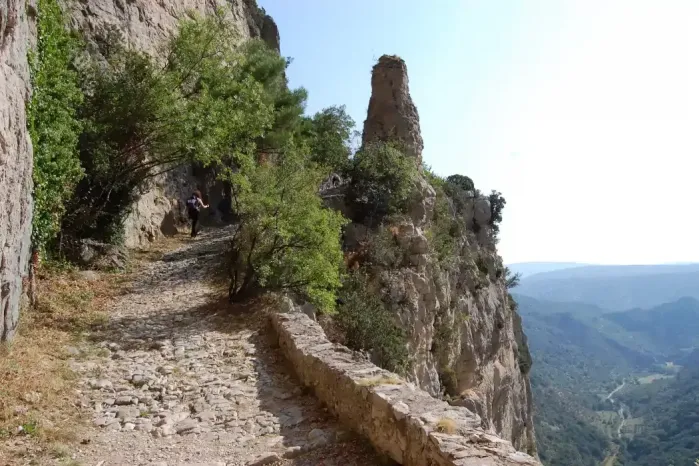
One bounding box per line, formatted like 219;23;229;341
513;264;699;311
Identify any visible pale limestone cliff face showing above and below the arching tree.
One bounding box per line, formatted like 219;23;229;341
64;0;279;248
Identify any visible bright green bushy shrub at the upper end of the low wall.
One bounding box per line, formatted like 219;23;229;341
230;150;345;312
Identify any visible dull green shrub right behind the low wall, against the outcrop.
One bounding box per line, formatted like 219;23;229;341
336;272;409;374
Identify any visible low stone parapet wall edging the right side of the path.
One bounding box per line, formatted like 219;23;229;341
271;310;540;466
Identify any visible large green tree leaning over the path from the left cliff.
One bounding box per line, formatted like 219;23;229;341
63;14;286;240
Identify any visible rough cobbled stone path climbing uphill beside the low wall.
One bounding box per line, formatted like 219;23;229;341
73;230;381;466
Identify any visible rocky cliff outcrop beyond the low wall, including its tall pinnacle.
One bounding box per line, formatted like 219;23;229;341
354;56;536;453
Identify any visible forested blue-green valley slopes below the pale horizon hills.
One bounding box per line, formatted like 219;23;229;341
517;296;699;466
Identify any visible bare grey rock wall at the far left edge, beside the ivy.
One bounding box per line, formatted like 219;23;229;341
0;0;36;341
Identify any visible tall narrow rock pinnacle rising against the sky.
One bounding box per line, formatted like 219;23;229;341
362;55;423;162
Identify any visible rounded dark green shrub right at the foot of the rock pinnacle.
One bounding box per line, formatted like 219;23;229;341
349;143;418;224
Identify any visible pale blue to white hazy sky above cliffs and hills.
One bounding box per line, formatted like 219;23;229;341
260;0;699;264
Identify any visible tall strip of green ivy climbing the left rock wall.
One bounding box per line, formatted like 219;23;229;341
28;0;83;252
